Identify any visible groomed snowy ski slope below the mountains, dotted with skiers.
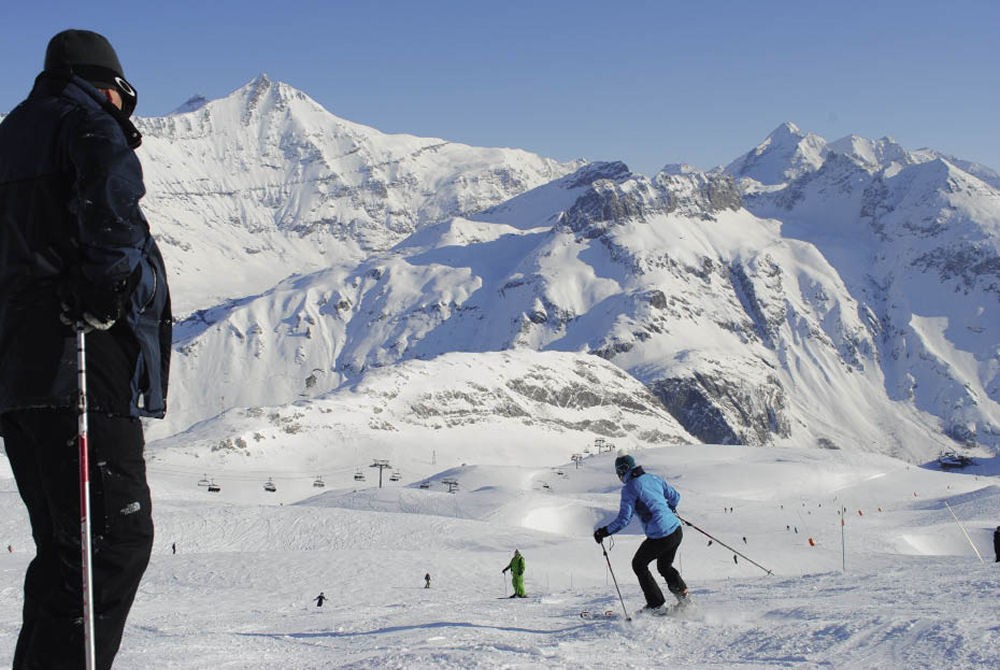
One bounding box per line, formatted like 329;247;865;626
0;438;1000;670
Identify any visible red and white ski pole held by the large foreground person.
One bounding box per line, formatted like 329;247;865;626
76;321;97;670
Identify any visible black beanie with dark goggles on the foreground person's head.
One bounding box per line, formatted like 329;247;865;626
45;30;138;116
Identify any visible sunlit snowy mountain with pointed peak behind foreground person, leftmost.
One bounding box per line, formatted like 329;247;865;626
136;75;580;313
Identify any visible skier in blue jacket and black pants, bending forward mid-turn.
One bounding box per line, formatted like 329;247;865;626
594;455;690;610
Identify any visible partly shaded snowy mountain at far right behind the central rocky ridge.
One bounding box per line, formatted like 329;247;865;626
727;124;1000;456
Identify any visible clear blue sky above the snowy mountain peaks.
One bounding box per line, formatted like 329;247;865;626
0;0;1000;174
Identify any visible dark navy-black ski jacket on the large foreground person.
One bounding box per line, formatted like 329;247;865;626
0;72;172;417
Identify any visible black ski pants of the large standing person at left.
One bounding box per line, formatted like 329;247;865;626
0;409;153;670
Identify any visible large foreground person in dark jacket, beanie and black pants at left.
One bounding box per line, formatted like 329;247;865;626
0;30;172;668
